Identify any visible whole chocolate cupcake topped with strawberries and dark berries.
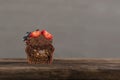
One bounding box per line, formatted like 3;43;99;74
23;29;54;64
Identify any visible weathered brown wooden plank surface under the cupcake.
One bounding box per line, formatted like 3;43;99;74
0;59;120;80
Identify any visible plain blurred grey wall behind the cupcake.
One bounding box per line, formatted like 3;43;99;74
0;0;120;58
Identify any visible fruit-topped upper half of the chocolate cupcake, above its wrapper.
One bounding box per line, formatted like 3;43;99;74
23;29;53;45
